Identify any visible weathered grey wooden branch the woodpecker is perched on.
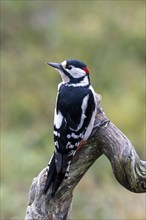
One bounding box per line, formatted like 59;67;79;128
25;95;146;220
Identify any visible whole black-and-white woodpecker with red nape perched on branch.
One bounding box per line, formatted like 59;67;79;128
44;59;96;196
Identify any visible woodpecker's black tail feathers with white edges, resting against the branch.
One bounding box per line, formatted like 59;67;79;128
44;152;73;197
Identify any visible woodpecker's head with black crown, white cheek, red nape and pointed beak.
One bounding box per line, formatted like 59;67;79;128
47;59;89;83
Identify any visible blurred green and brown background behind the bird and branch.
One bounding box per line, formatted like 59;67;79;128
1;0;146;220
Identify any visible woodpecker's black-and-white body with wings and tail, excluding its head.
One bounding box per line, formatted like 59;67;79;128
43;84;95;195
